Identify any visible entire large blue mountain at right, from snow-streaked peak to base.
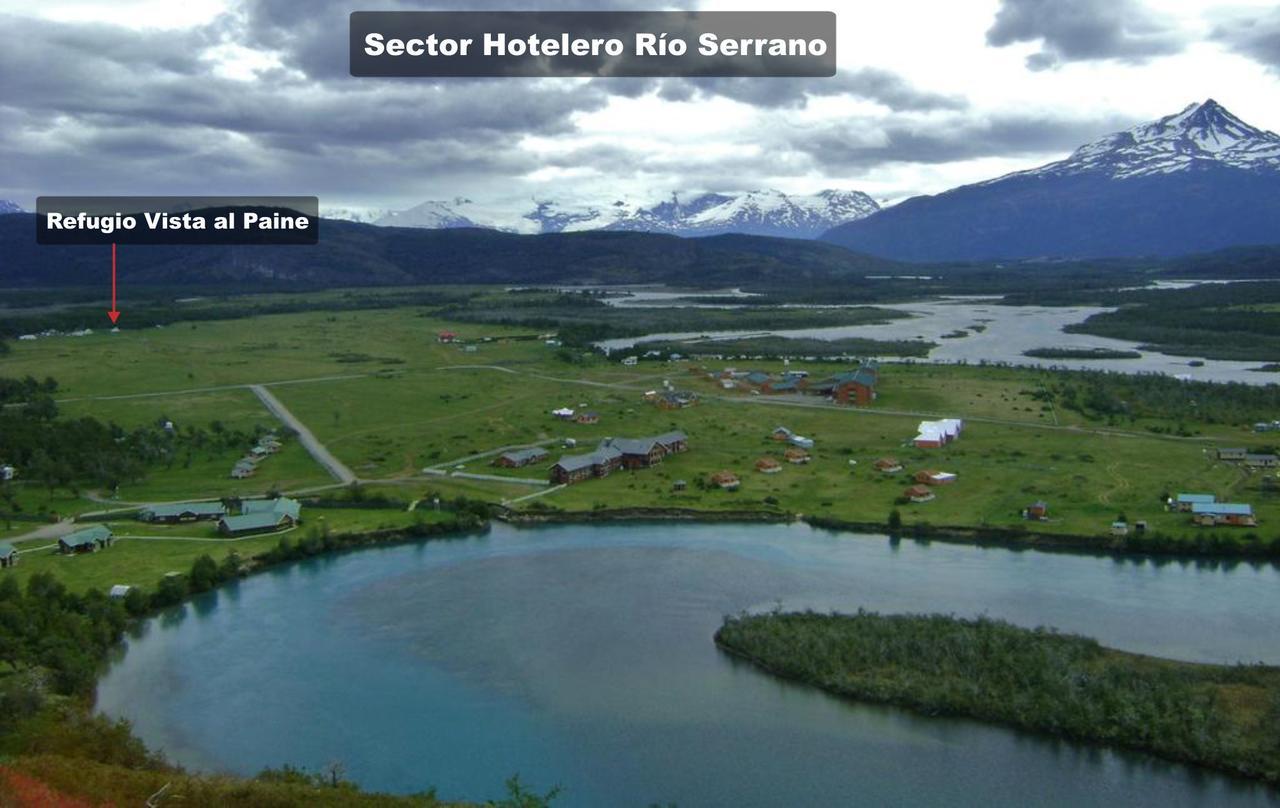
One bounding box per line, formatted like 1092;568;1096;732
822;100;1280;261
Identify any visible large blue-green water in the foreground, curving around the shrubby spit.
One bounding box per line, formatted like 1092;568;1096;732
99;524;1280;808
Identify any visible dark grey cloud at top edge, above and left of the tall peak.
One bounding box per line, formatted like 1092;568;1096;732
987;0;1187;70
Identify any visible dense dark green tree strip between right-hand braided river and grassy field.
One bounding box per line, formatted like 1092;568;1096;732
1032;370;1280;425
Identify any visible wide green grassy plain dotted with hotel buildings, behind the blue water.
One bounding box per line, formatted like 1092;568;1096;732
0;297;1280;594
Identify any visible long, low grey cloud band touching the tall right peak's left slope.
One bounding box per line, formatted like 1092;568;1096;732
790;115;1134;172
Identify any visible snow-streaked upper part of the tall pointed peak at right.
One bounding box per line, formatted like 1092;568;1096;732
997;99;1280;182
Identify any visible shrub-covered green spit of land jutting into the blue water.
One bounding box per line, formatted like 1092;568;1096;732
716;612;1280;784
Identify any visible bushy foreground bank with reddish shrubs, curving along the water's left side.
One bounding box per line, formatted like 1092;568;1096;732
0;512;494;808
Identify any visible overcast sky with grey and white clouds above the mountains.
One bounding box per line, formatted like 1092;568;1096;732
0;0;1280;217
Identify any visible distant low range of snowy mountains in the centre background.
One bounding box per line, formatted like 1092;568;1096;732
374;190;879;238
